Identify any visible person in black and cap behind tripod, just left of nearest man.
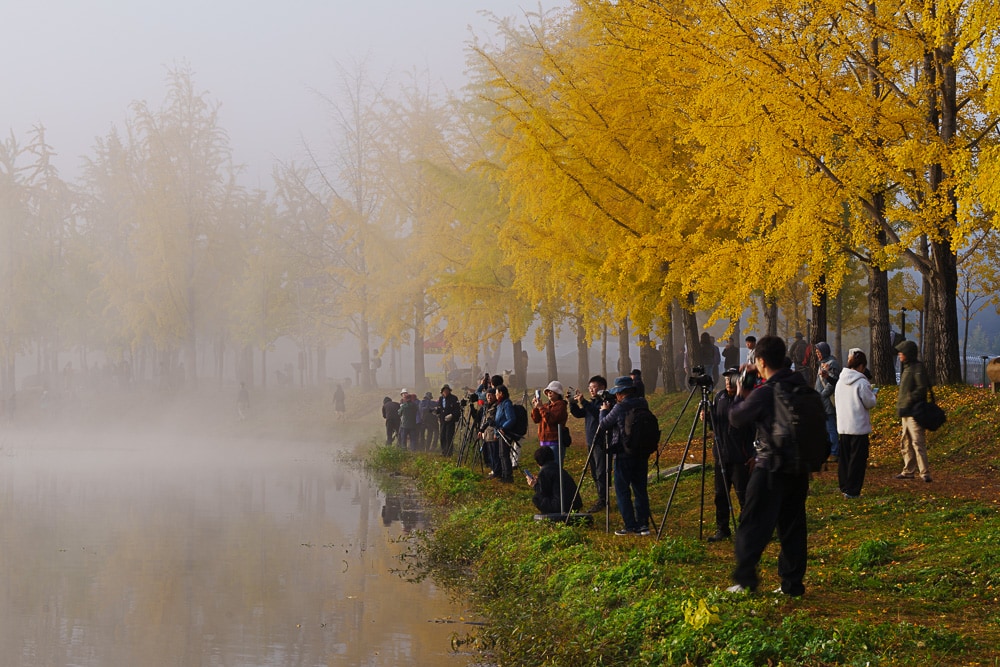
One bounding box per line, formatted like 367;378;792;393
701;368;755;542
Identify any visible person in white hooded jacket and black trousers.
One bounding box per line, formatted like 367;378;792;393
834;349;875;498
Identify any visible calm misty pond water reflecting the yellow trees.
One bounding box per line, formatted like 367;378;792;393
0;433;468;667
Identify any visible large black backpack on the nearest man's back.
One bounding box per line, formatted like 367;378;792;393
769;382;830;473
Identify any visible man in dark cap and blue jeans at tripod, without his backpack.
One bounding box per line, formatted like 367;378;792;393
600;375;649;535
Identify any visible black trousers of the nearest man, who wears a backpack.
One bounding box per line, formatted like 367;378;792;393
733;468;809;595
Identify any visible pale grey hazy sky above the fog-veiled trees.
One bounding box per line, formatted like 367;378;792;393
0;0;569;187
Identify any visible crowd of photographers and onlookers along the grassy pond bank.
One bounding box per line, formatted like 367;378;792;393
374;333;931;596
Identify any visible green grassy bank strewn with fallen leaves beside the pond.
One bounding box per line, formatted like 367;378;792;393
369;387;1000;666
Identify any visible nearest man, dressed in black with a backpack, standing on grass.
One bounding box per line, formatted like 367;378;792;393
727;336;829;596
